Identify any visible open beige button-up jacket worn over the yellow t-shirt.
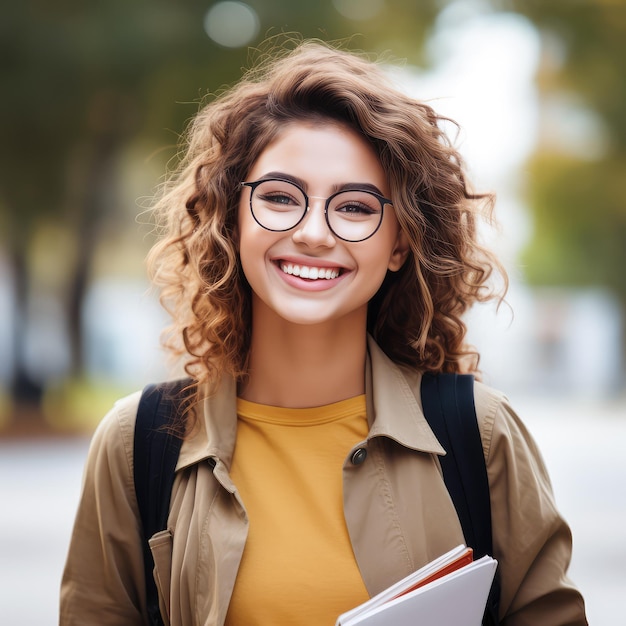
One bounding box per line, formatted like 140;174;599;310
60;341;587;626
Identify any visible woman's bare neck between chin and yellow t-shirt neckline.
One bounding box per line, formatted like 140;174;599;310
239;304;367;408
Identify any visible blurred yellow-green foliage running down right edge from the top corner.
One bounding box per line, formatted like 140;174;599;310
510;0;626;302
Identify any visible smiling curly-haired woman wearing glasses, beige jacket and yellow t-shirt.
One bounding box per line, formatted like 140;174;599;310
61;42;586;626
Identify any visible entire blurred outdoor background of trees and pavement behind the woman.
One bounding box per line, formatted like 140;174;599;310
0;0;626;626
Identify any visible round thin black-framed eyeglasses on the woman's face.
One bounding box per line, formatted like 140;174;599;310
241;178;391;242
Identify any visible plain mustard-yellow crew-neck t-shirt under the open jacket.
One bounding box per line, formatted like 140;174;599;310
226;395;369;626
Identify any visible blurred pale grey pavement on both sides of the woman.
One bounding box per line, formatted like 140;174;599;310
0;398;626;626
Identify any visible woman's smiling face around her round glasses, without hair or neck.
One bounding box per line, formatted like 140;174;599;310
238;122;408;324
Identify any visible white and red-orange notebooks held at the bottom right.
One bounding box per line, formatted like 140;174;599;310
336;545;497;626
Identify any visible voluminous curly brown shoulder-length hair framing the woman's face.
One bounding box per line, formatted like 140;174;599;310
148;41;507;392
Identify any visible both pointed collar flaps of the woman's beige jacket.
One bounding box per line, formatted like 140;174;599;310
176;337;445;470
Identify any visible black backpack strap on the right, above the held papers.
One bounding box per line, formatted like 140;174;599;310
421;374;500;626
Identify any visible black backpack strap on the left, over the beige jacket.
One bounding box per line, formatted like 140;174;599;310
133;379;191;626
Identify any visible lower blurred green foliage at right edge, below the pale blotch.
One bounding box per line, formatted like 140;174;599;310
525;154;626;298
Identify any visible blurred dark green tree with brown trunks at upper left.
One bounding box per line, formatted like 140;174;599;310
0;0;442;414
